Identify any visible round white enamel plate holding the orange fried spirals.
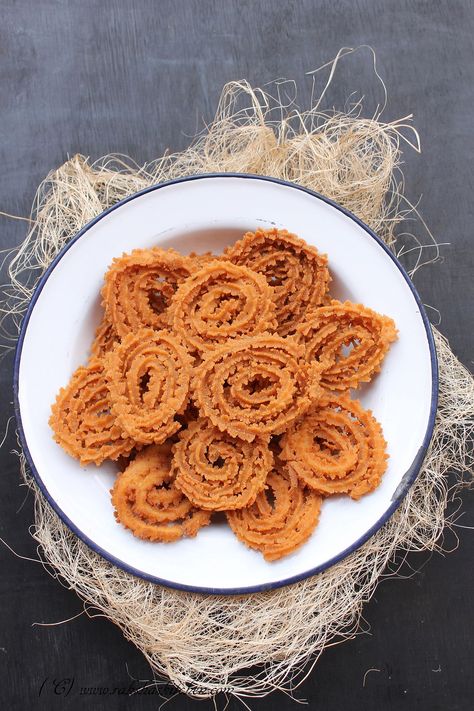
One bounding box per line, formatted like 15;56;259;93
14;174;438;593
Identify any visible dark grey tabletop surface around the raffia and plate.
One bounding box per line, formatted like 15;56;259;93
0;0;474;711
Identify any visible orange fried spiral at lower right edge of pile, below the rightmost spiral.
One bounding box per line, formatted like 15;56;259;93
280;394;388;499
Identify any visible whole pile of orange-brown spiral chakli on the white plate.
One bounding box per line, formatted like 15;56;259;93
50;228;397;561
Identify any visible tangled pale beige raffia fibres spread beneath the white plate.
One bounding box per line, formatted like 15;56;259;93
3;62;474;698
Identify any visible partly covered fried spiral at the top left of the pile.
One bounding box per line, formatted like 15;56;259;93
101;247;193;338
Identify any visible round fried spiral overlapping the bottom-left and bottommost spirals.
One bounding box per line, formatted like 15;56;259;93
172;419;273;511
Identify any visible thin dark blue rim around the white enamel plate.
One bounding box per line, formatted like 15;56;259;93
13;173;439;595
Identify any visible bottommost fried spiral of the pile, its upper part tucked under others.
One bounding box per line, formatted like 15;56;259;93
227;464;322;561
